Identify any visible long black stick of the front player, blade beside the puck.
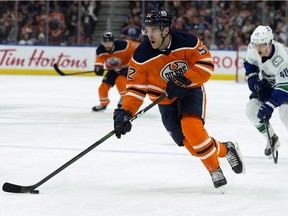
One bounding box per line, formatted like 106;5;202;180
2;94;166;194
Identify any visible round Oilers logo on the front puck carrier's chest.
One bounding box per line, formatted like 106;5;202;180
161;61;188;81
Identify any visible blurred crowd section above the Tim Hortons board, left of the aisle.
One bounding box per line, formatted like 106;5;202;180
0;1;101;46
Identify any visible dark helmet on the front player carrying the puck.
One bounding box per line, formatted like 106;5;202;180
144;11;172;28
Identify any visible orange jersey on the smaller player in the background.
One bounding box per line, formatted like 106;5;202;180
94;40;139;69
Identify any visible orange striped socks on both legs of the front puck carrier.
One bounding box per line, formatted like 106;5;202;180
181;114;227;172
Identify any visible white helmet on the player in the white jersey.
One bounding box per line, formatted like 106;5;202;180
250;25;273;44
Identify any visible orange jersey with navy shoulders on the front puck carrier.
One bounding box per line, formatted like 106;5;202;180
122;30;214;115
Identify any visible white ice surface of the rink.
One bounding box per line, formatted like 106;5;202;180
0;75;288;216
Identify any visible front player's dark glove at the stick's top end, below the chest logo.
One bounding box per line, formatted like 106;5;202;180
166;74;192;99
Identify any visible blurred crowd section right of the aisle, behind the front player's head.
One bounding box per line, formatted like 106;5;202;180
122;0;288;50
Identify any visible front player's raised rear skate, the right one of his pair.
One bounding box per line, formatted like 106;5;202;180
224;141;245;174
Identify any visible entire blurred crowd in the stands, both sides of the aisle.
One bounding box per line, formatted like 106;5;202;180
0;0;288;50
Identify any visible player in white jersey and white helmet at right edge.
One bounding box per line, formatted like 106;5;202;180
244;25;288;158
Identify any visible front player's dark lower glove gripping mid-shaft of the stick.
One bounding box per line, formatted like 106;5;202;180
113;108;132;139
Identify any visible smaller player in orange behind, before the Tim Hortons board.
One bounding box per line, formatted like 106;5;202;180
92;32;139;112
